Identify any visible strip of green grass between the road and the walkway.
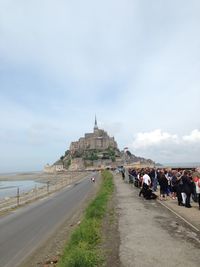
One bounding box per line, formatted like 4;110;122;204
58;171;114;267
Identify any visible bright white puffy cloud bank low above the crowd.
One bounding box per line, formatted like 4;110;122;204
129;129;200;163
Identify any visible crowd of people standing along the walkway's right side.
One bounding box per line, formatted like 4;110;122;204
126;168;200;210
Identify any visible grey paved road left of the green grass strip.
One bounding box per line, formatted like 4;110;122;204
0;176;97;267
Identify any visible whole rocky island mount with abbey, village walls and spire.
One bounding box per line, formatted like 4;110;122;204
44;116;154;173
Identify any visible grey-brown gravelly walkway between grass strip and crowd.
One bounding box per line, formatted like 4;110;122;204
114;174;200;267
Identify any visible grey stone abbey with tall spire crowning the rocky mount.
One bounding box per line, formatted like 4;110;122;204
70;117;118;156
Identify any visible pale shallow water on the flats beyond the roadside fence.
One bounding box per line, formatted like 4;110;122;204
0;180;44;199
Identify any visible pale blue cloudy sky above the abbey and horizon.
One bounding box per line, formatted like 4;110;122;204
0;0;200;173
